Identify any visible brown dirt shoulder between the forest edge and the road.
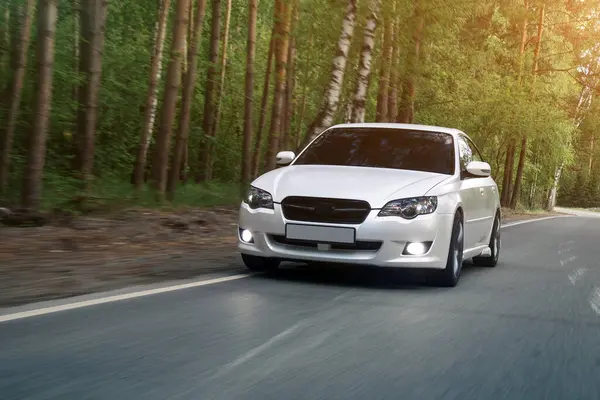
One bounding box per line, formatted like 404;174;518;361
0;207;564;307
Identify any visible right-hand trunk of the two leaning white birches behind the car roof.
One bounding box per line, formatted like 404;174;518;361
351;0;380;123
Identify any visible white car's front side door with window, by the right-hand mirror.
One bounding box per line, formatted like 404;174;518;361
457;135;488;249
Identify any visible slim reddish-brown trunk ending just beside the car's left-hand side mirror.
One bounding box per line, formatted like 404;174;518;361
265;0;291;171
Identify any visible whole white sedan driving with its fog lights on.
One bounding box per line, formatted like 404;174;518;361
238;124;500;287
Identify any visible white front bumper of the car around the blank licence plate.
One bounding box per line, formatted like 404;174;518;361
238;203;454;269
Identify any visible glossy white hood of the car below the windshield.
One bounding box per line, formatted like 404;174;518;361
252;165;451;208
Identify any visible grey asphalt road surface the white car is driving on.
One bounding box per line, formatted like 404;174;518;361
0;217;600;400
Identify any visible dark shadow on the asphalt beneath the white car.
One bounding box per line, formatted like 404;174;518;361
255;261;479;290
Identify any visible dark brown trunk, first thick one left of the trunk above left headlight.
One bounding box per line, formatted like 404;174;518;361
196;0;221;182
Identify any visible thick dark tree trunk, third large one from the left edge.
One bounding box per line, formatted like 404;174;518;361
75;0;108;185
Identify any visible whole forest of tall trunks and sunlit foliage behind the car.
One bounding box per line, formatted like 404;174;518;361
0;0;600;209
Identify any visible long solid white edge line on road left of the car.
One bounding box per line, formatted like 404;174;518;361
0;274;252;322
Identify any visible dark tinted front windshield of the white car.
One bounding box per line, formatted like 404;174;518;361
294;128;454;175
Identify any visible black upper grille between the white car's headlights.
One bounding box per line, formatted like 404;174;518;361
281;196;371;224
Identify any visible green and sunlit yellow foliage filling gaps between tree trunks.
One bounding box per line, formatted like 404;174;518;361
0;0;600;208
